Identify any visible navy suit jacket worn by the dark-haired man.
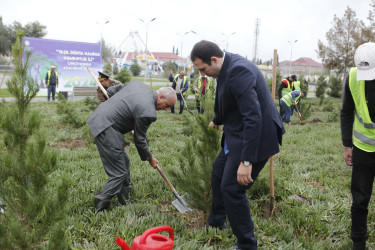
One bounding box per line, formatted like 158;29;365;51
213;52;285;165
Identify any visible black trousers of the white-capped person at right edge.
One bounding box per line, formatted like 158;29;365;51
351;147;375;241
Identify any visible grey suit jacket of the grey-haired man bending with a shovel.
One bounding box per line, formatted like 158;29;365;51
87;81;157;161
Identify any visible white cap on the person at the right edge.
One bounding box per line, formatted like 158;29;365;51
354;43;375;81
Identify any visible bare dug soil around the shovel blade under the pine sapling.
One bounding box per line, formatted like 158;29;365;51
159;202;207;230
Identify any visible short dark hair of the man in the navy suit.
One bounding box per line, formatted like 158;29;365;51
190;40;224;65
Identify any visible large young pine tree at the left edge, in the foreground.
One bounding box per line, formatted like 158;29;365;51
0;31;68;249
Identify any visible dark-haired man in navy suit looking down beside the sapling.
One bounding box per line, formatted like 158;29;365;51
190;40;284;249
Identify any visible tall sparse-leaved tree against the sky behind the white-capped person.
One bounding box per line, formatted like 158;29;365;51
317;6;364;77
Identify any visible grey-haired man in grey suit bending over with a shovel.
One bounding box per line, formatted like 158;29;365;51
87;81;177;211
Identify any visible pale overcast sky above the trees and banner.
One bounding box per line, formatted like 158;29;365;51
0;0;371;62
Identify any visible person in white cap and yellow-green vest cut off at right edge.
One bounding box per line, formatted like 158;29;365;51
340;43;375;249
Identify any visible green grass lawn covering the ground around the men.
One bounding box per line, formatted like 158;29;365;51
0;98;375;249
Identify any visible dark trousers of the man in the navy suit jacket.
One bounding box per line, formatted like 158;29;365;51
208;150;267;249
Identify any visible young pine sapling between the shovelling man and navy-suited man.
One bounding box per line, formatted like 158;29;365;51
170;93;220;218
